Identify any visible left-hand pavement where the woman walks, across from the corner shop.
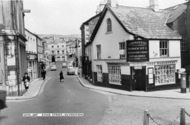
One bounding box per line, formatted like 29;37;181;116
6;77;50;101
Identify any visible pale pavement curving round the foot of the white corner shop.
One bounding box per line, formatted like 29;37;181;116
77;76;190;100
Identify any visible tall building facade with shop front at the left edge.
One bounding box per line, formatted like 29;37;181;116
0;0;27;95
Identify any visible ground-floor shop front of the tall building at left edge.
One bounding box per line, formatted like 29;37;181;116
0;34;26;95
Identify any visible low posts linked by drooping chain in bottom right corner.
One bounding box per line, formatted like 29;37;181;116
143;108;190;125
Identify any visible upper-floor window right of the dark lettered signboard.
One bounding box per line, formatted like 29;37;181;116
160;40;169;56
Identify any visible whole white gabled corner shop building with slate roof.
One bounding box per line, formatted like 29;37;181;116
81;0;181;91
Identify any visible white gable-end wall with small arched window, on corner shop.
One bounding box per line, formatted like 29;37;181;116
92;11;131;72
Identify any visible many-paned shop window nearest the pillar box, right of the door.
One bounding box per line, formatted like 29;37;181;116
155;64;175;85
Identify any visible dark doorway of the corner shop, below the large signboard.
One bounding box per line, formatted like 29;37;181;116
134;67;146;90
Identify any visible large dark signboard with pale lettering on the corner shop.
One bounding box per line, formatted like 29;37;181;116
127;40;149;62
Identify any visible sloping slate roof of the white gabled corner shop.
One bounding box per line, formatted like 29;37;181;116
110;6;181;39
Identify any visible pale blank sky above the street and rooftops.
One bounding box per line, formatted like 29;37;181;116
23;0;185;35
